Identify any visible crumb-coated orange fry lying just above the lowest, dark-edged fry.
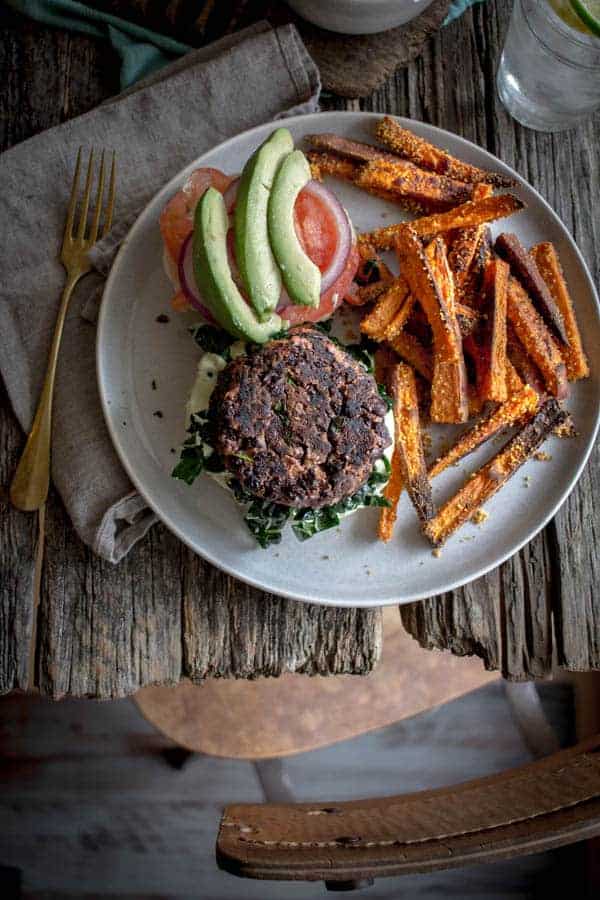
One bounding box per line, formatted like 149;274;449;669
429;385;540;479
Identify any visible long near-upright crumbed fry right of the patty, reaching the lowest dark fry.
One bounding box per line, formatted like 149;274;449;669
390;363;434;522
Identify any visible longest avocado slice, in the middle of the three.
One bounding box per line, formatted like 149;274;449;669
234;128;294;319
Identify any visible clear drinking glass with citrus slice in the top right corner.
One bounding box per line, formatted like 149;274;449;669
497;0;600;131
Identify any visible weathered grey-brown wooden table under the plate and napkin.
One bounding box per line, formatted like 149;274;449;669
0;0;600;698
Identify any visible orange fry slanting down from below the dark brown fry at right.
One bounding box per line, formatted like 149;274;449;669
507;276;569;400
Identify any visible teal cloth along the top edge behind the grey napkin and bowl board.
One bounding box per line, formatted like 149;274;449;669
6;0;483;90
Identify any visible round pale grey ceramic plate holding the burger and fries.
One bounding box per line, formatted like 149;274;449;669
98;112;600;606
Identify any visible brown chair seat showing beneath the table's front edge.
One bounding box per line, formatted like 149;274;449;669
135;607;499;759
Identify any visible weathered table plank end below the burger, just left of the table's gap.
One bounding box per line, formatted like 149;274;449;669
181;551;382;682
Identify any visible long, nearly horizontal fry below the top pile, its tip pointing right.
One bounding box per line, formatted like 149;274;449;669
363;194;525;250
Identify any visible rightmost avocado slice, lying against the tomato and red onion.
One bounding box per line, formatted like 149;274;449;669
267;150;321;308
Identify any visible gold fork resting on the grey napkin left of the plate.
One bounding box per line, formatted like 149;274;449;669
10;147;116;510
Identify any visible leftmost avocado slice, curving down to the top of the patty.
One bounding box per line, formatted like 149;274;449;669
193;187;283;344
